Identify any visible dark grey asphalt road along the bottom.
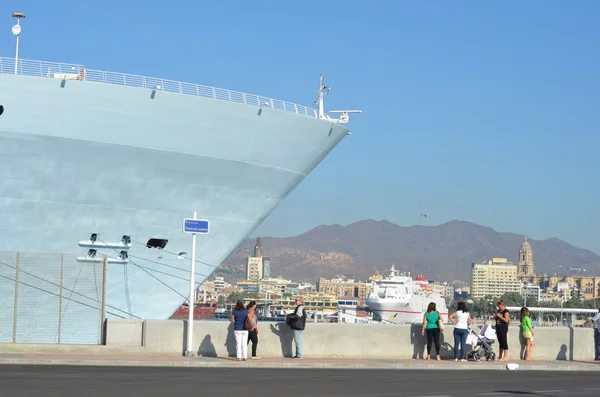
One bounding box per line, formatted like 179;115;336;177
0;365;600;397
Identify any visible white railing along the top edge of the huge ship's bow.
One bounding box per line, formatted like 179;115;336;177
0;57;317;118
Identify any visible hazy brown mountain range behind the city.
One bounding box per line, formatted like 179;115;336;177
223;220;600;283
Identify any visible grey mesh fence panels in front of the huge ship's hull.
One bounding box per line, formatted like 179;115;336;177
0;252;107;344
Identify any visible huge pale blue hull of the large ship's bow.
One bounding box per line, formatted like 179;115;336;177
0;70;348;341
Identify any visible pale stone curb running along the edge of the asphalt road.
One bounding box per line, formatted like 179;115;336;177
0;358;600;372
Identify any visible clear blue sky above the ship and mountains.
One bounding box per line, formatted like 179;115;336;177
0;0;600;253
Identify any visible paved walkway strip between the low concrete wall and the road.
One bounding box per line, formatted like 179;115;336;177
0;353;600;371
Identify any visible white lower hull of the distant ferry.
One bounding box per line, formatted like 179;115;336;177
365;295;448;324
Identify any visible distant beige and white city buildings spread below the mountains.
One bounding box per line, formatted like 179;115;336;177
212;232;600;312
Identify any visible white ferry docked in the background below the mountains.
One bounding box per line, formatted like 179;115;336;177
365;266;448;324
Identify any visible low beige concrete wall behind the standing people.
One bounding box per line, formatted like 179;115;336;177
107;319;594;361
